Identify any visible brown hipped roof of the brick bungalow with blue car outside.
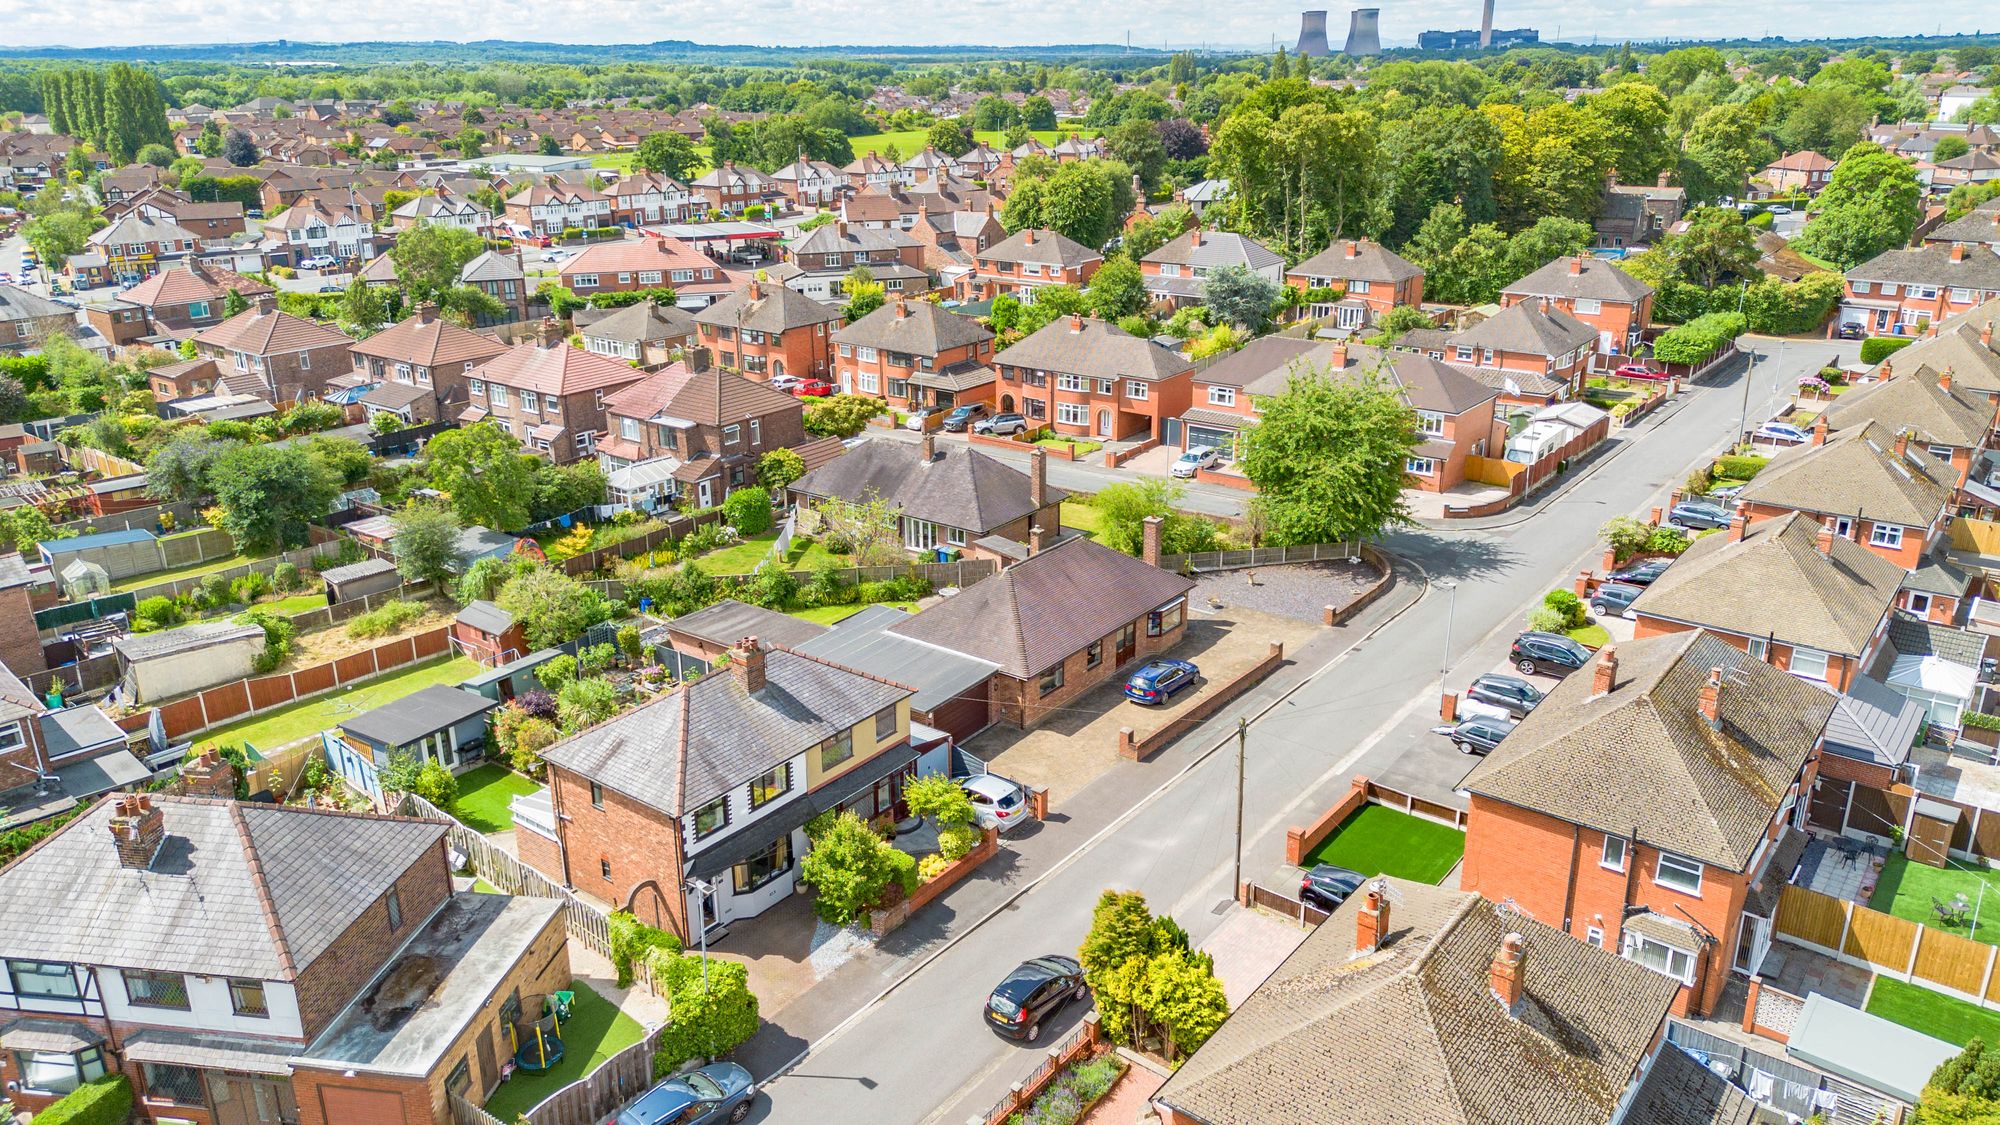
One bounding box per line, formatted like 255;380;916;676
888;532;1194;679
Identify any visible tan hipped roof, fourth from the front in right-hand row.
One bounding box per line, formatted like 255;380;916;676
1738;418;1958;528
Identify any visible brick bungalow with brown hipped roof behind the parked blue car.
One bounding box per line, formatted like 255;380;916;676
888;532;1194;729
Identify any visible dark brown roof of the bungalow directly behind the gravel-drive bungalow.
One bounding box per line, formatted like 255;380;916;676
792;440;1068;536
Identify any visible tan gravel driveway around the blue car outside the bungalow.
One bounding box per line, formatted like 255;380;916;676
966;599;1320;809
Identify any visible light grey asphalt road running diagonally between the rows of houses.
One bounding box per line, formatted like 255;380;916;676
756;342;1854;1125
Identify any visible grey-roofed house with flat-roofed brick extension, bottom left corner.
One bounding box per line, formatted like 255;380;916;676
0;788;570;1125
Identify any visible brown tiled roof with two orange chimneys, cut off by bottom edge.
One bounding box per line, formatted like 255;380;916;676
1154;879;1678;1125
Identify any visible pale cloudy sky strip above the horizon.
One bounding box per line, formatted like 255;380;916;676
0;0;2000;48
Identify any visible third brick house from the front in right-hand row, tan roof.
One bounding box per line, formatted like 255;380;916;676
1632;512;1904;691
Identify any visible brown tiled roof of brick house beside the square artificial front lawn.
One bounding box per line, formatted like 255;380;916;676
1462;632;1834;871
